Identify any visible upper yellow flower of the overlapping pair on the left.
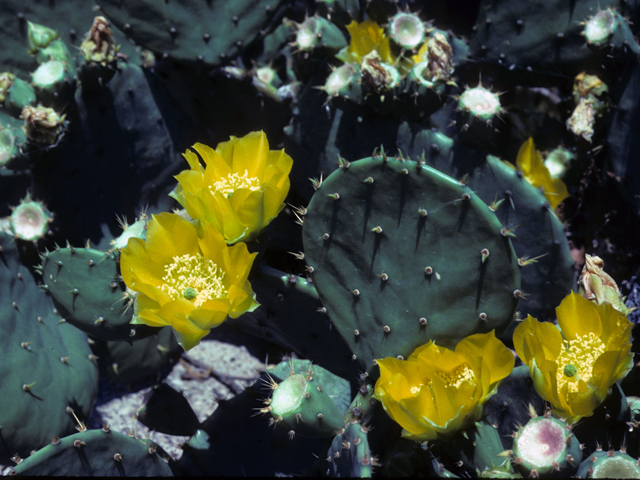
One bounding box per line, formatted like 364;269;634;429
171;132;293;245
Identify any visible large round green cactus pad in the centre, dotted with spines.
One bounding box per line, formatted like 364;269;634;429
302;153;521;368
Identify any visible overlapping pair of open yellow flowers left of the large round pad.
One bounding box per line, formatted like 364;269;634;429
120;132;293;350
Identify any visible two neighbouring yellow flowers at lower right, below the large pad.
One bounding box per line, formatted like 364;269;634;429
374;293;633;441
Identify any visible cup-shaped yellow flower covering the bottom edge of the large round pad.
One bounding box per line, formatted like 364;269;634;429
374;331;515;441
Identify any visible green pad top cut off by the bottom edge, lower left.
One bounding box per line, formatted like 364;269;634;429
12;426;173;477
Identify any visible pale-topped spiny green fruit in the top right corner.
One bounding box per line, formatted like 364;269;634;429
582;8;640;55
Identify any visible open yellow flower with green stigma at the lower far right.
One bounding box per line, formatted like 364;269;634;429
513;292;633;423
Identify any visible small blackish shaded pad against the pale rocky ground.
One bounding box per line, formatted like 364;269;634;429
136;383;200;436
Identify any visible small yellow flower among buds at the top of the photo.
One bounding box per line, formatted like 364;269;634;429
336;19;397;65
